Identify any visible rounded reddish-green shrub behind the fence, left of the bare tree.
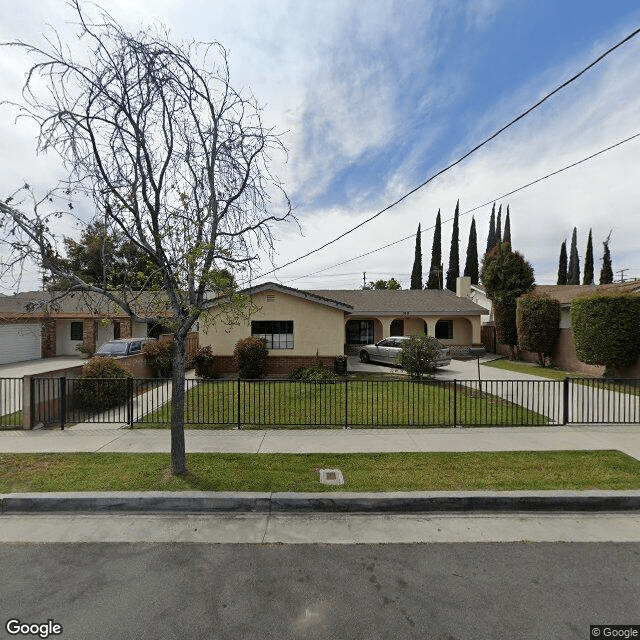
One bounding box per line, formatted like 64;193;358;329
73;356;133;411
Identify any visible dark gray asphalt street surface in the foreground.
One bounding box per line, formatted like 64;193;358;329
0;542;640;640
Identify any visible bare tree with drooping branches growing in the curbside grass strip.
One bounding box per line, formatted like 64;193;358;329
0;0;292;474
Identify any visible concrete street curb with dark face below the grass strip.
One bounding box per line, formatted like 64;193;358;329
0;490;640;514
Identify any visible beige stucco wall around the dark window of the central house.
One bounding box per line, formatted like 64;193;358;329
200;291;345;357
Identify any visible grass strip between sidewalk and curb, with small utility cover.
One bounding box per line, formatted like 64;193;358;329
0;450;640;493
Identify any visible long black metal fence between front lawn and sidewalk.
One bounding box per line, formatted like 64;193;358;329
20;378;640;428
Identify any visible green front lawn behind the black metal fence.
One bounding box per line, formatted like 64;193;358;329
135;380;549;429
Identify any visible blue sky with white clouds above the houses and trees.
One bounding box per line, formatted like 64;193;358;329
0;0;640;289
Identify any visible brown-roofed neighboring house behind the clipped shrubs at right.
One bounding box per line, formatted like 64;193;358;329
498;280;640;378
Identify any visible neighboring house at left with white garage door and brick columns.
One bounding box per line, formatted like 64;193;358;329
0;291;168;364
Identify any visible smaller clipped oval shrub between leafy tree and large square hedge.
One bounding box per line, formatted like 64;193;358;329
516;293;560;366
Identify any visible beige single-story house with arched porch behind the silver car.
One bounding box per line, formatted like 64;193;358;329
200;282;487;375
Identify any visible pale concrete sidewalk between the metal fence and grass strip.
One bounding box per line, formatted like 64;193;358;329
0;425;640;460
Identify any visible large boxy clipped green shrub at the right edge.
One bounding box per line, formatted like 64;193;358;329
571;294;640;376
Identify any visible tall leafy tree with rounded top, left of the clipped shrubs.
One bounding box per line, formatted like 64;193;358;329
482;243;535;357
